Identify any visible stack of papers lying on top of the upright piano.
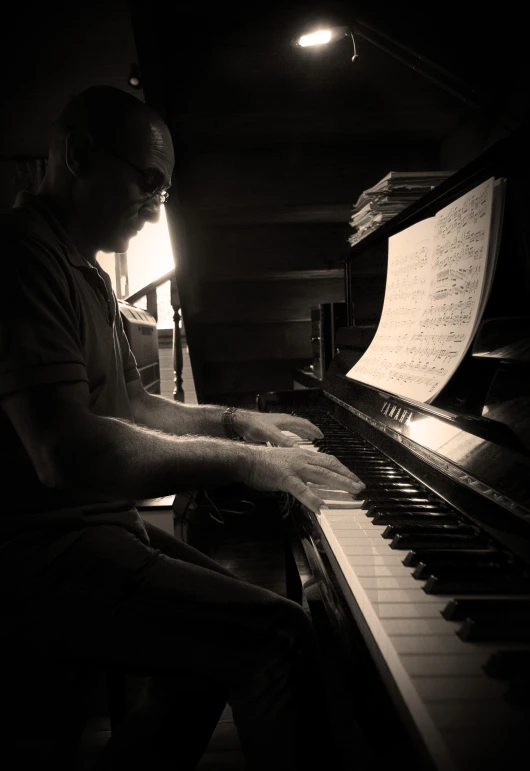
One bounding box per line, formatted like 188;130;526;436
348;171;453;246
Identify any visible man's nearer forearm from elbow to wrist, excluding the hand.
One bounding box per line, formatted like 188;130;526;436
56;418;252;499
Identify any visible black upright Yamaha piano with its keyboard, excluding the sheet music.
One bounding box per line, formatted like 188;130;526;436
258;130;530;771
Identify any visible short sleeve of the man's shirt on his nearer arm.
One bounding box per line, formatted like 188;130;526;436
0;242;88;396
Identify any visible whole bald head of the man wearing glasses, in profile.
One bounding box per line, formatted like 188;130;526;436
41;86;174;252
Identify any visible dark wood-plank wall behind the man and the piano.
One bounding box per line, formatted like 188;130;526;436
0;0;528;403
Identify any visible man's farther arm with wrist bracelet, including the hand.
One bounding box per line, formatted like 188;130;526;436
127;379;322;447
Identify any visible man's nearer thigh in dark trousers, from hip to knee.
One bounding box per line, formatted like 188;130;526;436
8;526;308;682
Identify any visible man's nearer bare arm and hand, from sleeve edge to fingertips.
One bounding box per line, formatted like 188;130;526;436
1;381;362;511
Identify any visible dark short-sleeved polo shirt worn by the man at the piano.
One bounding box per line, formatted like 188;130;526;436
0;193;149;574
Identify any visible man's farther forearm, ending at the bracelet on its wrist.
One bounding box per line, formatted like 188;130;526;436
135;394;246;438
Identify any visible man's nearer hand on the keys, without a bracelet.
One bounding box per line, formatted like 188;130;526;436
243;446;365;514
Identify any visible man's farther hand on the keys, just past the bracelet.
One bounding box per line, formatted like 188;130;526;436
234;410;323;447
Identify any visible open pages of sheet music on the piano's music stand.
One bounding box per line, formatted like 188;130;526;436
347;177;494;402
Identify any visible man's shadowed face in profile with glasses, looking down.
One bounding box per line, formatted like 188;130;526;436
81;120;174;253
